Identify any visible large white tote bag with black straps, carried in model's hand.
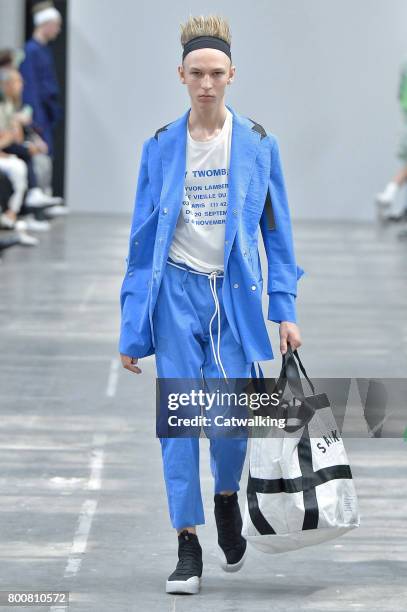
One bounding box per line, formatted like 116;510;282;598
242;348;360;553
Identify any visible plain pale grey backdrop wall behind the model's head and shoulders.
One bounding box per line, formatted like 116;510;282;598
68;0;407;219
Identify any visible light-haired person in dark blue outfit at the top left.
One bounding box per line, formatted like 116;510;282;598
20;2;63;157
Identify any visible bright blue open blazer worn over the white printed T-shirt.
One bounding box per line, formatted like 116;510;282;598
119;104;304;363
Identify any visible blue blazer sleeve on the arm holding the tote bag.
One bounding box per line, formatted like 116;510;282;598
260;136;304;323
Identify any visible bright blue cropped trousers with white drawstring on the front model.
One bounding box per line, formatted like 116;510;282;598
153;262;252;530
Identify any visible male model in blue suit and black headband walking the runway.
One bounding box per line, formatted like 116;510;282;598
119;15;303;593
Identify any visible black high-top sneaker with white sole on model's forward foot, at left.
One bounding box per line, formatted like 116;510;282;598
165;529;202;595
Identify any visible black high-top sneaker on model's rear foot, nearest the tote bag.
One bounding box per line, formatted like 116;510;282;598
214;491;247;572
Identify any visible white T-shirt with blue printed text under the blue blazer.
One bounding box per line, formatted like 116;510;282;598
169;108;233;272
